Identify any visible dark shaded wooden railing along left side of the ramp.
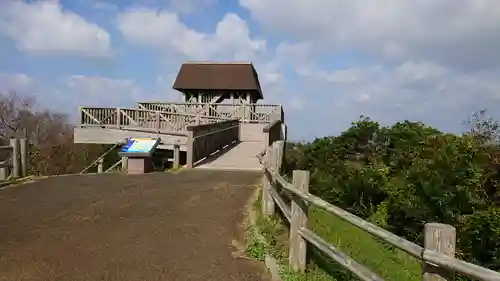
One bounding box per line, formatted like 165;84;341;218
186;119;240;168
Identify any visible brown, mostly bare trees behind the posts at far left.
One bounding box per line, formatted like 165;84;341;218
0;93;110;175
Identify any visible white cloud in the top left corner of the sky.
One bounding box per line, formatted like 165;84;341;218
0;0;111;56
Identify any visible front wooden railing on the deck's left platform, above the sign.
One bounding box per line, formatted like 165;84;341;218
80;107;229;133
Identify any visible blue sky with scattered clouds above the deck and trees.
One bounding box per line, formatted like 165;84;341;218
0;0;500;140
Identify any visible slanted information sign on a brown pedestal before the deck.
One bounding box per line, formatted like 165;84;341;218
118;138;160;174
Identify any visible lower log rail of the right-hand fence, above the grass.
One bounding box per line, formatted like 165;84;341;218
299;228;384;281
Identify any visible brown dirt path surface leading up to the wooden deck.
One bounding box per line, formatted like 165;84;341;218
0;170;268;281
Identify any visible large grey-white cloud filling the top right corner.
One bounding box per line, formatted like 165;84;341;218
240;0;500;69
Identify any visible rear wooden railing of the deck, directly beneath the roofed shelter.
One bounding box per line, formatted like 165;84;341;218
138;102;284;123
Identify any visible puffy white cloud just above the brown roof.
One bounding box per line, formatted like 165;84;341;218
117;8;266;60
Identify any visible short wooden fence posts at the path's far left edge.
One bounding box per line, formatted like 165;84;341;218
0;138;28;180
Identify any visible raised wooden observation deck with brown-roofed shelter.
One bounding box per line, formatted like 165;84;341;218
74;62;286;166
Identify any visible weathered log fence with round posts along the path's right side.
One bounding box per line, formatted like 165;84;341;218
257;141;500;281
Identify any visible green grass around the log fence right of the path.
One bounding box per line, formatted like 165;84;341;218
246;185;421;281
